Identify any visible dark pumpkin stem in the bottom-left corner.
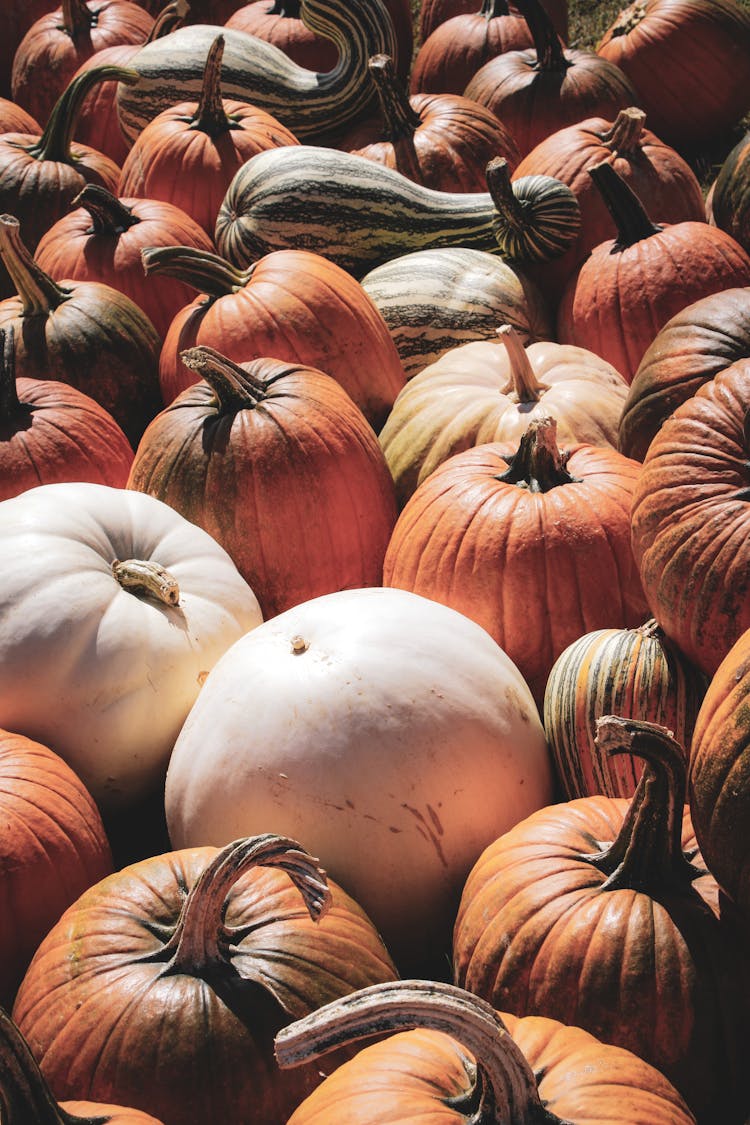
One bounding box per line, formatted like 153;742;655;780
0;1008;99;1125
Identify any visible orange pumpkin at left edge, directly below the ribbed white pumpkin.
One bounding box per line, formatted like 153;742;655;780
0;730;112;1008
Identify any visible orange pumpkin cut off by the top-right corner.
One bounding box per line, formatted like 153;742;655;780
597;0;750;151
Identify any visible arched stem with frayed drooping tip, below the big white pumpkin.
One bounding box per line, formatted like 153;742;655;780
159;833;332;975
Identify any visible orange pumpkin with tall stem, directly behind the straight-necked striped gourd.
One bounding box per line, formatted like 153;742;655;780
337;55;518;191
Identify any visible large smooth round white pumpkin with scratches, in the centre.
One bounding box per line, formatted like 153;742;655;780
165;587;552;973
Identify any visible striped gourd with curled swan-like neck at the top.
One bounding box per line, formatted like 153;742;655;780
118;0;397;142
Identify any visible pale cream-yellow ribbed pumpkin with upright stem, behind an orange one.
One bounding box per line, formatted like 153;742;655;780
380;324;627;506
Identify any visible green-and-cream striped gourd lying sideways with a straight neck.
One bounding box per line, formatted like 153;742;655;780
215;145;580;278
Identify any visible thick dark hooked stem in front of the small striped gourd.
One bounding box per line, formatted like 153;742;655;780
586;714;703;896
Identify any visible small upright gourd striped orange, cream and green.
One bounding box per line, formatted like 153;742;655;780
544;619;708;800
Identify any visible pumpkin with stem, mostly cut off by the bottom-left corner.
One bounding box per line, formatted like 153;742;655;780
0;1008;162;1125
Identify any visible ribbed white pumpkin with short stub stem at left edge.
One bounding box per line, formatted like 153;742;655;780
0;484;262;810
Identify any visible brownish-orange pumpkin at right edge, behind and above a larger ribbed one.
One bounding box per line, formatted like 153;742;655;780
618;288;750;461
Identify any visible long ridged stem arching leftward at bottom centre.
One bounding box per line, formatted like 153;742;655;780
274;980;568;1125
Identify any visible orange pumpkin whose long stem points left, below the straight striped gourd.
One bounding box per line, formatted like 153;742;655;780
142;246;405;429
